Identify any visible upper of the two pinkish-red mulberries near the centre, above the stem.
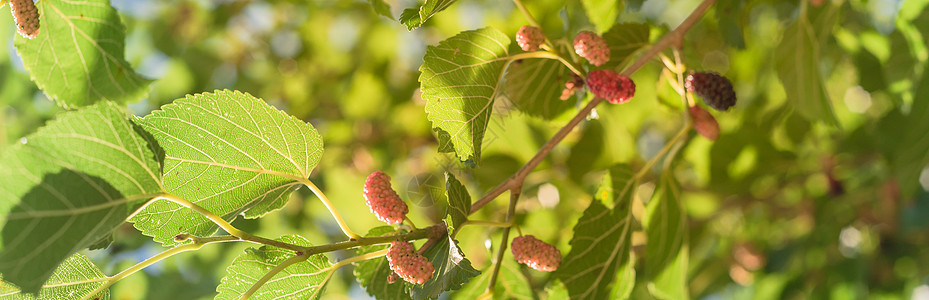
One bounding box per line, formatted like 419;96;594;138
364;171;410;224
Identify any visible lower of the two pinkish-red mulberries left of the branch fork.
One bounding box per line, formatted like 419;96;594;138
387;241;435;284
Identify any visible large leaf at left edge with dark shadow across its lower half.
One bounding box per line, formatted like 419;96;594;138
0;102;163;293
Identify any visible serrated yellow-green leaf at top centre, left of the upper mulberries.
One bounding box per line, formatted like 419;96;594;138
419;28;510;161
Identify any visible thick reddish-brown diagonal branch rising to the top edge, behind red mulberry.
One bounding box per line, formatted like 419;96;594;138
470;0;716;214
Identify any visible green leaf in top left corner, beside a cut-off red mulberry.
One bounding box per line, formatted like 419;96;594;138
15;0;151;107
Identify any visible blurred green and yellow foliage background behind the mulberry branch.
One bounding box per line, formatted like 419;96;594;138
0;0;929;300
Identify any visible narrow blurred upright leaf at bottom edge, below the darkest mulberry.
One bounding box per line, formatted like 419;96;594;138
644;175;689;299
